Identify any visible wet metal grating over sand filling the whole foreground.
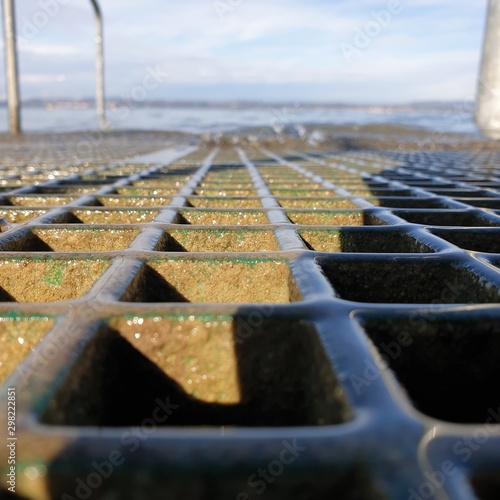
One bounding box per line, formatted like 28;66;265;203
0;142;500;500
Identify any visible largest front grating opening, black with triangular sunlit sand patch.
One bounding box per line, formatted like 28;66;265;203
42;312;350;427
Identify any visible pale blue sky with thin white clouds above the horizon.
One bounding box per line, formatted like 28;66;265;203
0;0;486;103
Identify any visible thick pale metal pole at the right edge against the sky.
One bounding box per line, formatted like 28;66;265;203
476;0;500;139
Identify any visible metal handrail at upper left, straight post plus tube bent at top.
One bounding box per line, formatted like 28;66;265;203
2;0;108;135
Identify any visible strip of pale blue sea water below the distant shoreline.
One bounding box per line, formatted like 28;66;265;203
0;104;478;134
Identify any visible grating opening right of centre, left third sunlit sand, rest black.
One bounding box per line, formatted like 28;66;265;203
299;228;433;253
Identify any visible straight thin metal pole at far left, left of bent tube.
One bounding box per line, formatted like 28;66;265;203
3;0;21;135
